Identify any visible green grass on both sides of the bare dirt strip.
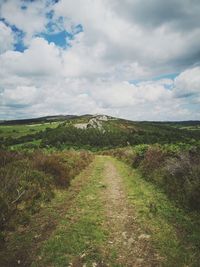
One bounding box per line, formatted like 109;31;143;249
0;156;200;267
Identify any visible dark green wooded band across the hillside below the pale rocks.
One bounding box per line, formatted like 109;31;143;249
0;120;200;150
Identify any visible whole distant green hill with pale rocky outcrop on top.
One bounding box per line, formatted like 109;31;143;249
0;114;200;149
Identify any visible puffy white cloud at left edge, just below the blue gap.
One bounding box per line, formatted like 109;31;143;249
0;38;61;77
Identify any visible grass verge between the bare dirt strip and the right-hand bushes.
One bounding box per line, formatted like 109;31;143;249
113;159;200;267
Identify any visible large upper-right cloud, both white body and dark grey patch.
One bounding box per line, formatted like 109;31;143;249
54;0;200;72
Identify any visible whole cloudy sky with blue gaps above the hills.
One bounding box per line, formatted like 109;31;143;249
0;0;200;121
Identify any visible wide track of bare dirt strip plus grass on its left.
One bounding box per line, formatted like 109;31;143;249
0;156;160;267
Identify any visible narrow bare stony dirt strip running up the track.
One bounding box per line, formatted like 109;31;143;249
102;160;159;267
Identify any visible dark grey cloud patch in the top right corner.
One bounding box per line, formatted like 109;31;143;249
113;0;200;31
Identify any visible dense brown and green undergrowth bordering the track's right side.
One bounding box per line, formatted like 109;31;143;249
104;144;200;211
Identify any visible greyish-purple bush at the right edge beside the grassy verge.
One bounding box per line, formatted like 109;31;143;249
162;153;200;210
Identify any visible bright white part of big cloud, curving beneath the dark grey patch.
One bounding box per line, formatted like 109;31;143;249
52;0;200;75
